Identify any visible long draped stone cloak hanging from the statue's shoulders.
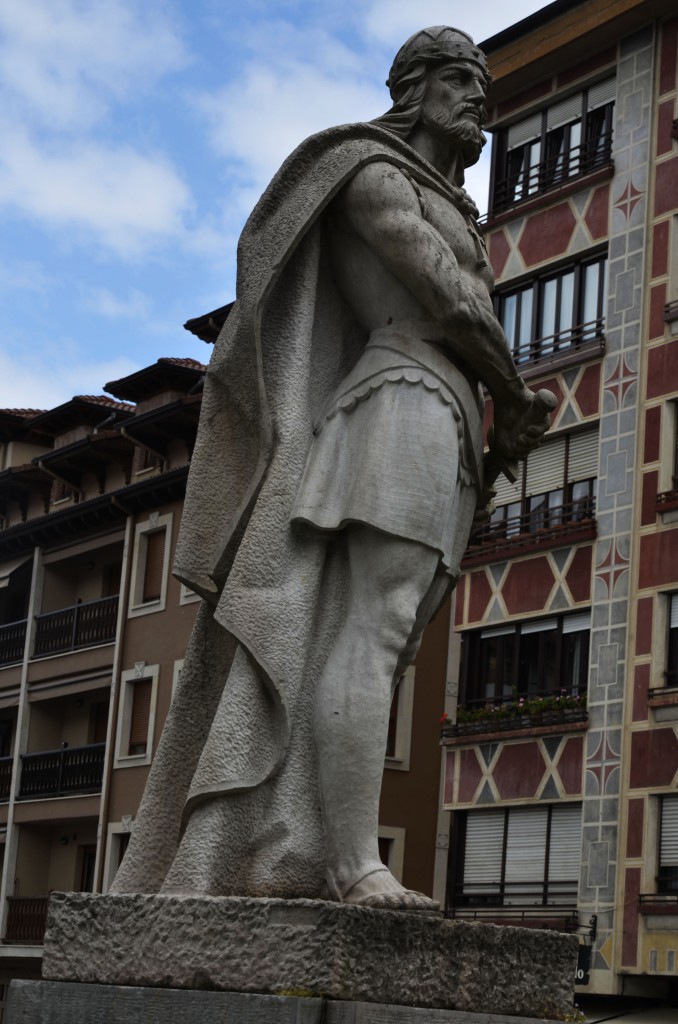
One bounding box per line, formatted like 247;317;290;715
113;124;489;897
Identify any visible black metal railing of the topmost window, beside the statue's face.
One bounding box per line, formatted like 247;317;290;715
492;131;612;216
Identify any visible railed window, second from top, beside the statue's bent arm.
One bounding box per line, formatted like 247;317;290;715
496;255;607;364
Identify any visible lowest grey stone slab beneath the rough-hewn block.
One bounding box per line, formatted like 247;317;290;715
5;981;573;1024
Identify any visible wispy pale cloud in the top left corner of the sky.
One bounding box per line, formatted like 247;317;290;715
0;0;187;130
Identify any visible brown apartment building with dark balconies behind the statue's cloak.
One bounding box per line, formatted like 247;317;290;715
0;346;451;1021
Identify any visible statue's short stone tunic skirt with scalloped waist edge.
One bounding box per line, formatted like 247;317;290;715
293;322;482;575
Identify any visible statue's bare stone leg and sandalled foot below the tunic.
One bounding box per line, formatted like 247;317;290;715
314;524;448;909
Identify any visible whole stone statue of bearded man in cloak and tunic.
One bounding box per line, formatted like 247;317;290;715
114;27;554;909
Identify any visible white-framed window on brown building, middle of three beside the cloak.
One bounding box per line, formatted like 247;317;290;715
116;662;159;768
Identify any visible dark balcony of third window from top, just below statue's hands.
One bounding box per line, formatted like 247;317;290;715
462;498;596;568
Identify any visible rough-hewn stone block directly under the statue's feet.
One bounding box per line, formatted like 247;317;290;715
42;893;577;1018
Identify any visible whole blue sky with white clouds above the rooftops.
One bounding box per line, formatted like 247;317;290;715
0;0;546;409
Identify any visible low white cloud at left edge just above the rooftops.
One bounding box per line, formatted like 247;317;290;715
0;345;139;409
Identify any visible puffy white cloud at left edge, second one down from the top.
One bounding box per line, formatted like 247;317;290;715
0;126;190;256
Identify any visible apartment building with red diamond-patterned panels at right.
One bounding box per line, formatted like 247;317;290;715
443;0;678;998
